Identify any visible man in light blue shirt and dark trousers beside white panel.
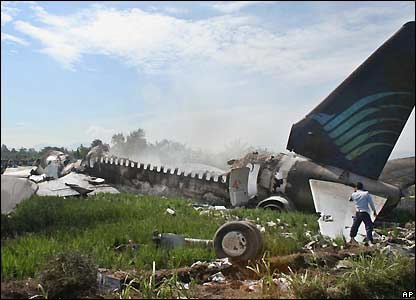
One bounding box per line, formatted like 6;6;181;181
350;182;377;246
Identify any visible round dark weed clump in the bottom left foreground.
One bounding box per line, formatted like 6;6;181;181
39;251;97;299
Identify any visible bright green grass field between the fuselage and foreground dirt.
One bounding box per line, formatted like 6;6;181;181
1;194;318;279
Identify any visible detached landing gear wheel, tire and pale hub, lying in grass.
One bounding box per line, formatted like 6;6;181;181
213;221;263;261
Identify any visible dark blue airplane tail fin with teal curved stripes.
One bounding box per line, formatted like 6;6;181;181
287;21;415;179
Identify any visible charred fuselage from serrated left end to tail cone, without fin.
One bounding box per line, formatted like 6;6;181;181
87;153;401;212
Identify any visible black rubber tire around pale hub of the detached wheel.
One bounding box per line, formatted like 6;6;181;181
213;221;262;261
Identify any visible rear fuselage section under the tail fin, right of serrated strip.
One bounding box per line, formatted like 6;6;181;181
234;153;401;212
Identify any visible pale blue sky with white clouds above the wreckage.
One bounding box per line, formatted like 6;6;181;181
1;1;415;157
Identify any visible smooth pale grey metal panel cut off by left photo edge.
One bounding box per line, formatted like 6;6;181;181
1;175;38;214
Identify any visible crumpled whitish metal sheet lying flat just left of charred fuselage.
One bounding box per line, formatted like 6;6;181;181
37;172;119;197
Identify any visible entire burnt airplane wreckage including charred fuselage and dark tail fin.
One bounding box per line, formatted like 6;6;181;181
87;21;415;239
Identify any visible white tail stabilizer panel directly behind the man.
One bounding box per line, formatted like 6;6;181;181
309;179;387;242
